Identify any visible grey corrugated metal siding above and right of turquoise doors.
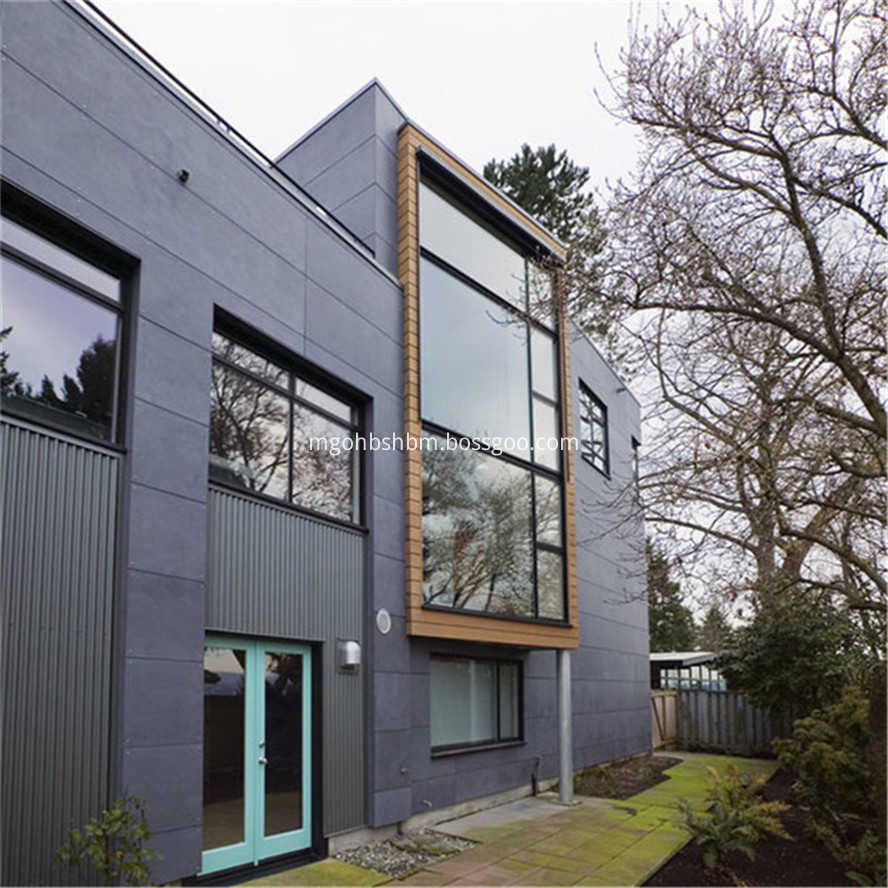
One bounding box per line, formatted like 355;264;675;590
207;489;365;835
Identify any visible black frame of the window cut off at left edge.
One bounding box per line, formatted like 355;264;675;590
0;191;131;453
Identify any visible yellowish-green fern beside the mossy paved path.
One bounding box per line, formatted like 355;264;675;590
678;765;790;868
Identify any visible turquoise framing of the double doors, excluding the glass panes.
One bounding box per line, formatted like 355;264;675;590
199;633;316;876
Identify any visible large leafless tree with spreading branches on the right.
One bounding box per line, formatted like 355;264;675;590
603;0;886;623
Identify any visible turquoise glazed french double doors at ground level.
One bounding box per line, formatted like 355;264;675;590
201;636;312;874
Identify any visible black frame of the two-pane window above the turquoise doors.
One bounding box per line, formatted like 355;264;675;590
208;320;367;531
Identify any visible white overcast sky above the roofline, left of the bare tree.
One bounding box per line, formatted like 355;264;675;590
93;0;680;199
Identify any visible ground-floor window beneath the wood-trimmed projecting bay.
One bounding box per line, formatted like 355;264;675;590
430;657;521;752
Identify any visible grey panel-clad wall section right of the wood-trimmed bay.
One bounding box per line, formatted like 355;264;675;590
571;330;651;768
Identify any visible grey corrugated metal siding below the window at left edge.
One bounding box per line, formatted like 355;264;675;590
0;422;119;885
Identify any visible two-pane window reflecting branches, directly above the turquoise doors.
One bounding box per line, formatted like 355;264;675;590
210;333;359;522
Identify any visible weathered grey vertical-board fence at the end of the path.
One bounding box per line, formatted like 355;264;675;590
678;690;795;755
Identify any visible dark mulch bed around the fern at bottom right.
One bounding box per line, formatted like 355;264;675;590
645;771;855;886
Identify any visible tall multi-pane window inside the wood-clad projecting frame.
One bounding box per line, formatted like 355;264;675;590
419;180;566;622
